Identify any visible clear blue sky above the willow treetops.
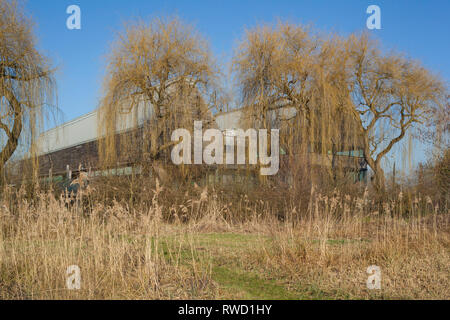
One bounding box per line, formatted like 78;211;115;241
25;0;450;170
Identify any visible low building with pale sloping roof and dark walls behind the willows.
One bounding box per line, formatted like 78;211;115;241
31;108;367;182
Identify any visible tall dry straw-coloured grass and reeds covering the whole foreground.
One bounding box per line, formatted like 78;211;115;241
0;183;450;299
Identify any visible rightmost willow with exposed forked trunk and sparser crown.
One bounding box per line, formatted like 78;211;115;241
346;34;446;191
